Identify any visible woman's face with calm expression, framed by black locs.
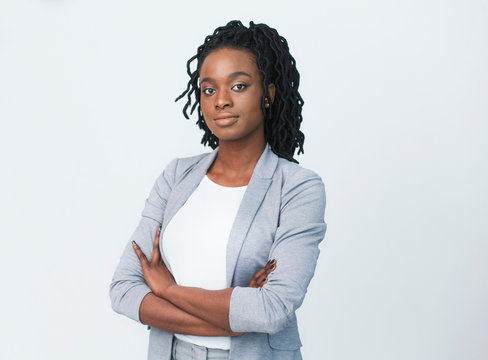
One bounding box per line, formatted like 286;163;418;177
200;48;274;143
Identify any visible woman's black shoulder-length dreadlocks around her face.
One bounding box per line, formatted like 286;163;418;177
175;20;305;163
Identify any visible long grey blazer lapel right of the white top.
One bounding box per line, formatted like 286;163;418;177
226;145;278;287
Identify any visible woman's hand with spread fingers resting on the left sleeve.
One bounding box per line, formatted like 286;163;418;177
132;228;176;298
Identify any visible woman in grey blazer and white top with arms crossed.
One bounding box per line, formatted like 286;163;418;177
110;21;326;360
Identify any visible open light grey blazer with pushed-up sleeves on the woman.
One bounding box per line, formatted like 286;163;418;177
110;146;326;360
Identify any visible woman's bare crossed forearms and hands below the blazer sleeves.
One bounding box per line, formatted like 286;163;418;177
132;228;276;336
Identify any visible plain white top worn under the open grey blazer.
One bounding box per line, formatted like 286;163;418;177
161;176;247;350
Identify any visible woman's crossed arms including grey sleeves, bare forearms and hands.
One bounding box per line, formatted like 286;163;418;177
110;162;326;336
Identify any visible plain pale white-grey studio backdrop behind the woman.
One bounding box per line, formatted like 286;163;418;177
0;0;488;360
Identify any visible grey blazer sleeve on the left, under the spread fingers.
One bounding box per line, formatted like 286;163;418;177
109;159;177;322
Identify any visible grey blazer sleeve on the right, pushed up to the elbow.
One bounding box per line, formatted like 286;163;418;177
229;168;326;334
